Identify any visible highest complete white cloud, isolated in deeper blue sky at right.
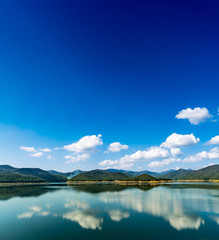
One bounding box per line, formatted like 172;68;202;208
176;107;213;125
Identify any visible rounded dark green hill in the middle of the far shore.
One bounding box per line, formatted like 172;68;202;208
70;170;128;181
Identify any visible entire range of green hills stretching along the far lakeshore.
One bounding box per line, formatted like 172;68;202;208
0;165;219;183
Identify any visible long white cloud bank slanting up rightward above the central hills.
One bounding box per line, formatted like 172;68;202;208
99;147;169;168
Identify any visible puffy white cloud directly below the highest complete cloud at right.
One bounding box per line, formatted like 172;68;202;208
161;133;200;148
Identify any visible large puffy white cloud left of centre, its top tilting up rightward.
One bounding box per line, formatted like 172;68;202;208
63;134;103;153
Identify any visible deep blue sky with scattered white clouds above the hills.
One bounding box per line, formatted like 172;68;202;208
0;0;219;171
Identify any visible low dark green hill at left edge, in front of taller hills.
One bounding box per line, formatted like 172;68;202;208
0;172;45;183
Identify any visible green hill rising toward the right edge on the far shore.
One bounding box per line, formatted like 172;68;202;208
162;165;219;180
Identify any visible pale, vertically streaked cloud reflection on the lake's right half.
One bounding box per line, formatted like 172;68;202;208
99;187;219;230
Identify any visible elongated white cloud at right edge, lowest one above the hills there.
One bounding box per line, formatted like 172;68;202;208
183;147;219;162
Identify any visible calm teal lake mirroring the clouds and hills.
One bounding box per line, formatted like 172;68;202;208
0;183;219;240
